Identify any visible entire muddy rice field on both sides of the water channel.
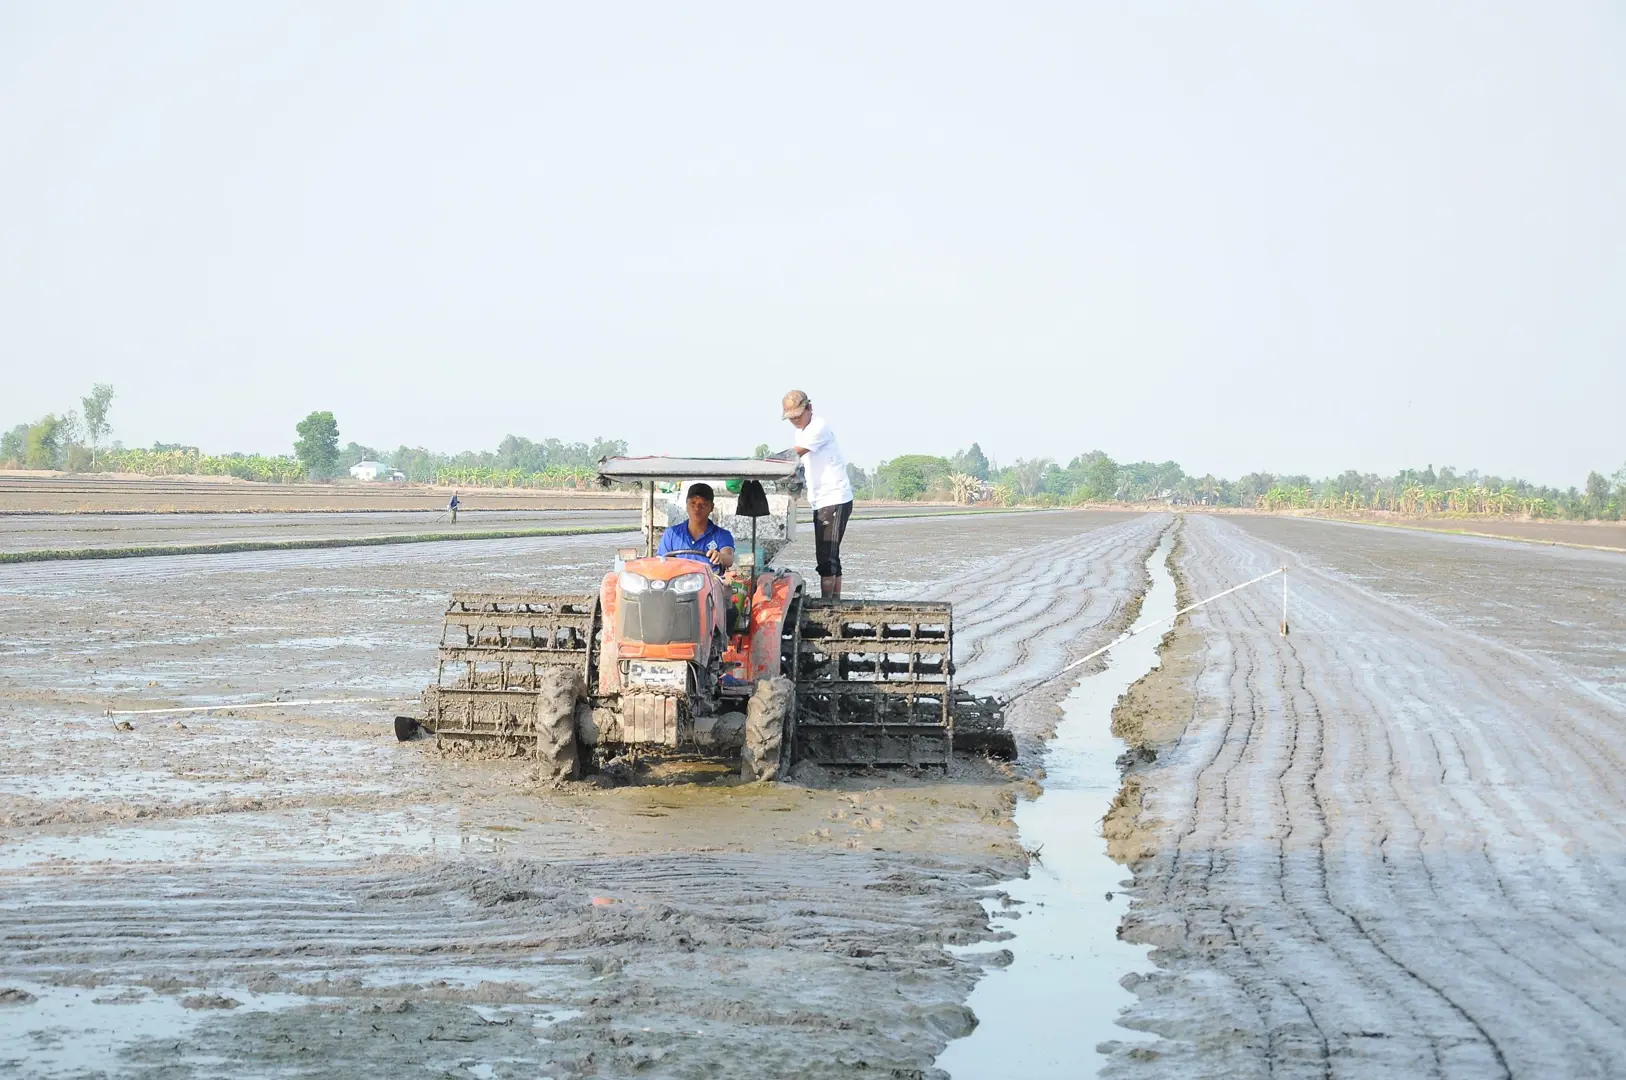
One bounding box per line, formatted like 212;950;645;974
0;507;1626;1078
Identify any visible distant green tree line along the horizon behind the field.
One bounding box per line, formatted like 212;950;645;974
0;384;1626;520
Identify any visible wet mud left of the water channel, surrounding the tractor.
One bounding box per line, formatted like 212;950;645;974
0;512;1169;1077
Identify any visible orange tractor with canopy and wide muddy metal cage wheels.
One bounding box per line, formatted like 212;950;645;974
395;457;1015;779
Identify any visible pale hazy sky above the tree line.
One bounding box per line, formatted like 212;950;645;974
0;0;1626;486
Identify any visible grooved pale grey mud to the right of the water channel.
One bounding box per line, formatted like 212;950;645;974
1111;516;1626;1077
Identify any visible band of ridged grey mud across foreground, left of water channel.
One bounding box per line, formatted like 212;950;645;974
0;852;997;986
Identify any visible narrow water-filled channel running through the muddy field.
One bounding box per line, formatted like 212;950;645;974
937;532;1174;1080
